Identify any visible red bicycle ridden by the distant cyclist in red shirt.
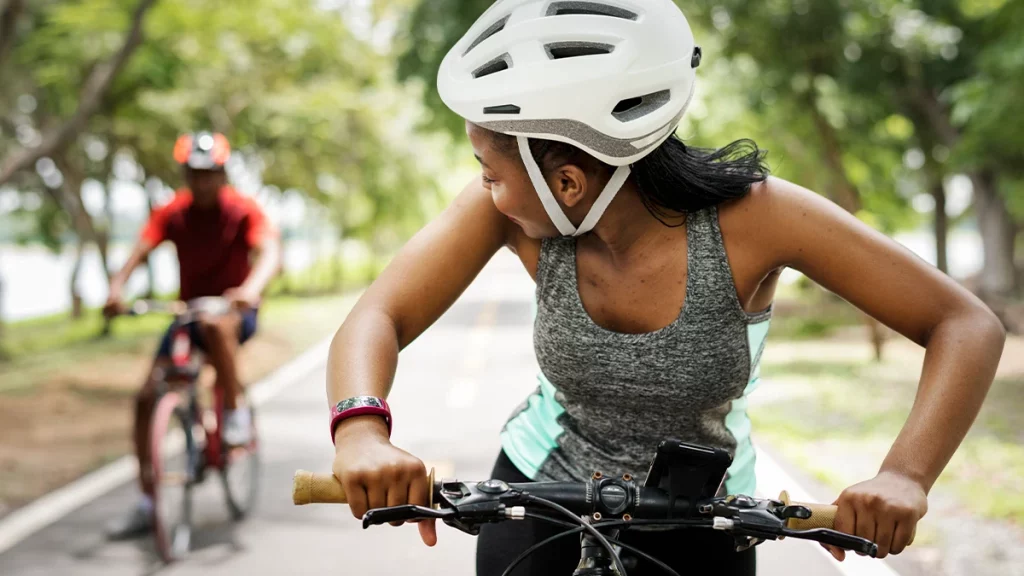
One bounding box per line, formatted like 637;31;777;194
129;297;259;562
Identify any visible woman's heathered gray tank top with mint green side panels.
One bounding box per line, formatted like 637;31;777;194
502;204;771;494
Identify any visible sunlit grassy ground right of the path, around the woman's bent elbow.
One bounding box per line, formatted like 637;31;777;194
751;328;1024;576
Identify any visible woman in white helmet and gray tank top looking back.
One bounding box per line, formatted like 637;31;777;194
328;0;1005;576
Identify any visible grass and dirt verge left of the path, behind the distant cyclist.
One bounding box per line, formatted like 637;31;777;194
0;296;354;517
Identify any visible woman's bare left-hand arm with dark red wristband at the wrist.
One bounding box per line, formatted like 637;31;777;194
325;178;515;545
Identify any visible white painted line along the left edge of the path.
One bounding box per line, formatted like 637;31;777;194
0;338;331;553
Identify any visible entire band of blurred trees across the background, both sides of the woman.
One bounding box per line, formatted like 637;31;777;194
0;0;1024;350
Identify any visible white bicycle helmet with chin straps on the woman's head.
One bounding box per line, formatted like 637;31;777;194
437;0;701;236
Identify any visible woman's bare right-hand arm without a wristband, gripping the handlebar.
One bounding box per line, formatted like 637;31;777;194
751;178;1006;557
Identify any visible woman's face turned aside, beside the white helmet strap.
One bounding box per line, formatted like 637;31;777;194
466;122;560;239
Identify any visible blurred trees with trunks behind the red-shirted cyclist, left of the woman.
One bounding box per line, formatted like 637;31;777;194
0;0;445;334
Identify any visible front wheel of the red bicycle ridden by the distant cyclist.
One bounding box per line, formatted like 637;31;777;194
150;392;198;562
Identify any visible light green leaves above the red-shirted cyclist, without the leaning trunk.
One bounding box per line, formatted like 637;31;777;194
0;0;445;264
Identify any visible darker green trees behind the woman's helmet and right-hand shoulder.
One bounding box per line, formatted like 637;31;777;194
398;0;1024;327
